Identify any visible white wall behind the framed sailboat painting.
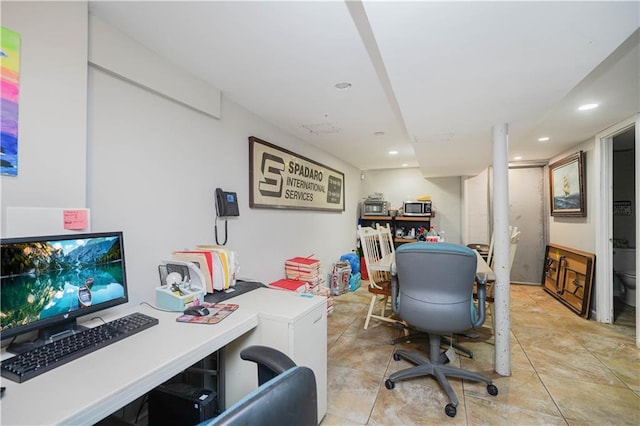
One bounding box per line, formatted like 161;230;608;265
545;139;596;253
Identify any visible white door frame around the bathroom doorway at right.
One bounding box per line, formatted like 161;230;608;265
594;114;640;348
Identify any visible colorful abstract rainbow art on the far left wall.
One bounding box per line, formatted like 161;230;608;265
0;27;20;176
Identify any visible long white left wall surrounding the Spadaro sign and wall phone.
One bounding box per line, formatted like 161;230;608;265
2;2;360;310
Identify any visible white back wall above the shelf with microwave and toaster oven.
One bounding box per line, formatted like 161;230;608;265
361;168;462;243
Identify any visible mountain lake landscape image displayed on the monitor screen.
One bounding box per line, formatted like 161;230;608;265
0;236;125;330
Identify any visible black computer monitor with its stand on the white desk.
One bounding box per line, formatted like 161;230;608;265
0;232;128;353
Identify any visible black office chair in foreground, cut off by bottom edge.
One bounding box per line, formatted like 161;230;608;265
201;346;318;426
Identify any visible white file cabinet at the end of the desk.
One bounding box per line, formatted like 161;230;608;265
222;288;327;422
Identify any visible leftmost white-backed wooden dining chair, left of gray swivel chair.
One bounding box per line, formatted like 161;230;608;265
358;226;396;330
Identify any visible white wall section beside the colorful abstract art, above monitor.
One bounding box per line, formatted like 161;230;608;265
0;1;87;216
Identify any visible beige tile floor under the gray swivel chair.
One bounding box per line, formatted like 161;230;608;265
322;285;640;426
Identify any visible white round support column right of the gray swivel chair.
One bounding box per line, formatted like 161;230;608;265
492;123;511;376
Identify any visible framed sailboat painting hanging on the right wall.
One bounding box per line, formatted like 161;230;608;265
549;151;587;217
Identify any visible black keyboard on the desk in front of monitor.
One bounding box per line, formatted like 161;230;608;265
0;312;158;383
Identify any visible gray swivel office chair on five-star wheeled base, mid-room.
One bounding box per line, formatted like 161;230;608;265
385;242;498;417
